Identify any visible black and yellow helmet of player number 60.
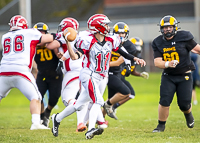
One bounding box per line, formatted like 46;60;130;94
159;15;179;37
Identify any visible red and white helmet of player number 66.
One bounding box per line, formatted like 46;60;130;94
8;15;28;31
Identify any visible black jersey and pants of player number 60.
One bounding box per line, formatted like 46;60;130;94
152;31;197;108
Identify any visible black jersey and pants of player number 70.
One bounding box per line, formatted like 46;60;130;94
35;43;63;110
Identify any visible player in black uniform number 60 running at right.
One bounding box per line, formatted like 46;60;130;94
152;15;200;132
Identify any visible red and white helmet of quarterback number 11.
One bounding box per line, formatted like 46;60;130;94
87;14;111;36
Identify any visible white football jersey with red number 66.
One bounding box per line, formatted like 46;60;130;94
1;29;42;69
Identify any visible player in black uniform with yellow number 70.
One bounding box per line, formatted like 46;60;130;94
33;22;63;127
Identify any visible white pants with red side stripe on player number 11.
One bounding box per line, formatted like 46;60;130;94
74;69;108;110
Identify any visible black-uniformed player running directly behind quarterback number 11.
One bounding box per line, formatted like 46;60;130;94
103;22;136;120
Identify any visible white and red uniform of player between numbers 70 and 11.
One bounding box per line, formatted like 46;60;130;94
57;32;83;106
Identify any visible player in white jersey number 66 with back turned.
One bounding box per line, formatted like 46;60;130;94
0;15;54;130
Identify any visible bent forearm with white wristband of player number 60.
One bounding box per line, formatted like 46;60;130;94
154;57;179;69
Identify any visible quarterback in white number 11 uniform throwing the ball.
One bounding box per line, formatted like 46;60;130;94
52;14;146;139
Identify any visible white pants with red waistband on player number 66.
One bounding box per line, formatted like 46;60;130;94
0;71;42;101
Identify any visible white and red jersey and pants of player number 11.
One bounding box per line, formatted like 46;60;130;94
75;31;120;107
